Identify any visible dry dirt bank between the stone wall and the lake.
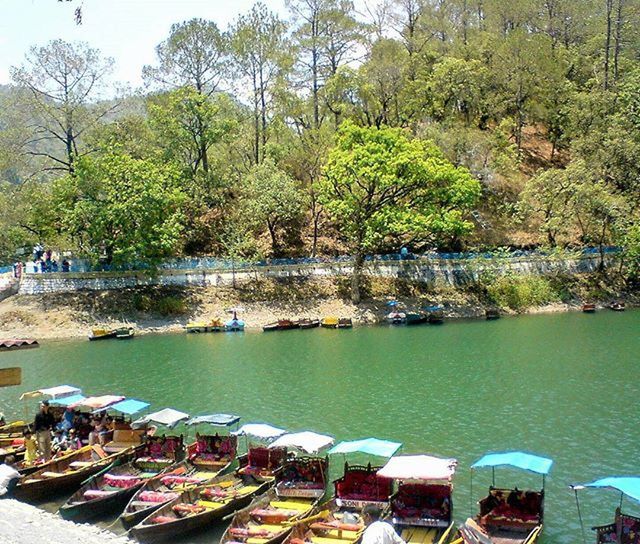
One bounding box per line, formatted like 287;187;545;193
0;278;637;339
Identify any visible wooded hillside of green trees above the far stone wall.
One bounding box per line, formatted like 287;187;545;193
0;0;640;280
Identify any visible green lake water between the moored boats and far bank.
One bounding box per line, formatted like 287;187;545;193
0;311;640;544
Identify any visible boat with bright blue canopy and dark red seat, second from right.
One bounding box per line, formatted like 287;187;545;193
456;452;553;544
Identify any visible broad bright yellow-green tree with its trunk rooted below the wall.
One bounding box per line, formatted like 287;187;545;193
321;123;480;303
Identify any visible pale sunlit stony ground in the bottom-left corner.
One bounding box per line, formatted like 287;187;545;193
0;499;132;544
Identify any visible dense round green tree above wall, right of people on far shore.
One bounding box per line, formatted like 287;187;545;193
54;149;185;265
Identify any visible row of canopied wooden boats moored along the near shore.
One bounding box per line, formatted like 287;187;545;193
0;386;640;544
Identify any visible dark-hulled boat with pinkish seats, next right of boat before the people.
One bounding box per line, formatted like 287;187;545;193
60;446;176;521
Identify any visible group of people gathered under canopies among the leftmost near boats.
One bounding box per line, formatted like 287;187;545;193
24;400;114;465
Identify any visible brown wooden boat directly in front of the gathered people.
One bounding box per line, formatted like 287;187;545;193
13;445;132;502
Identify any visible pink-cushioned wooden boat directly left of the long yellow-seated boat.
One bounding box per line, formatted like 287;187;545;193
120;435;237;527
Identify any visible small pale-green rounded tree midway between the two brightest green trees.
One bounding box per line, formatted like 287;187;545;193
240;159;306;256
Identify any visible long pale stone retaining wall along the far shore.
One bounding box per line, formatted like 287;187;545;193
13;256;599;295
